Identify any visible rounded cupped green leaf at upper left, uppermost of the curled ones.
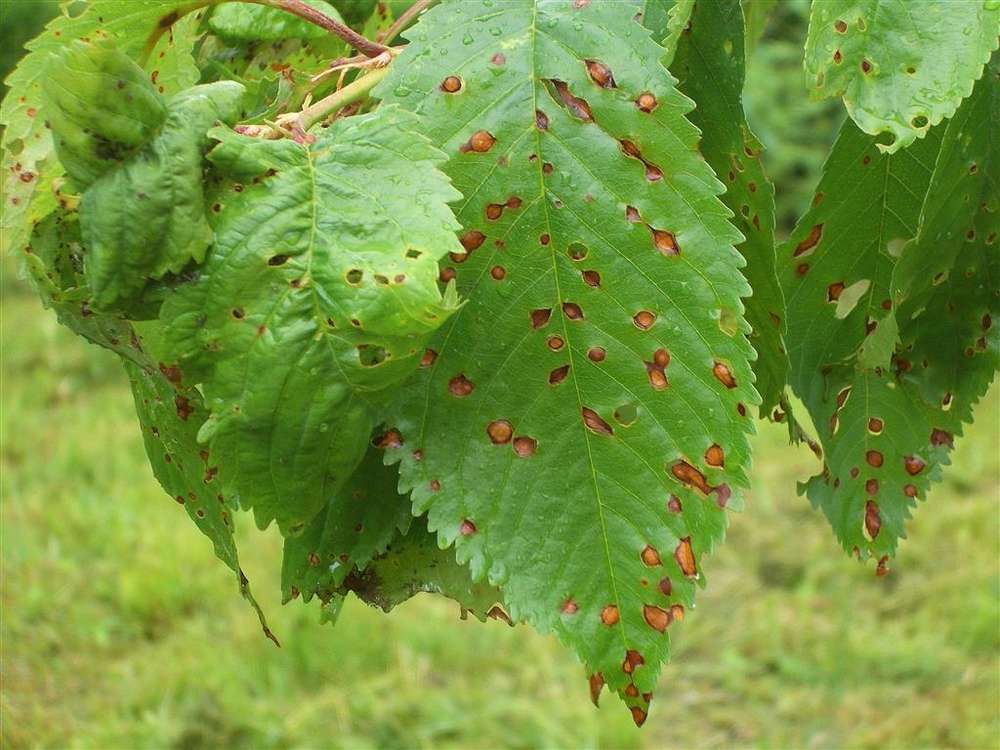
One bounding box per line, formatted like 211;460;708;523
42;40;167;189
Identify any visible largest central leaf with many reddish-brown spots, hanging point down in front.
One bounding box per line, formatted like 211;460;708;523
377;1;758;719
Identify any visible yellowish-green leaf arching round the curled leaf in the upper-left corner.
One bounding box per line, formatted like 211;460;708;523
0;0;217;252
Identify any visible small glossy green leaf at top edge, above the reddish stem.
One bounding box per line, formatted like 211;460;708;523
208;0;344;43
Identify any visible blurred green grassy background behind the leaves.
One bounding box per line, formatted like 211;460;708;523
0;0;1000;749
